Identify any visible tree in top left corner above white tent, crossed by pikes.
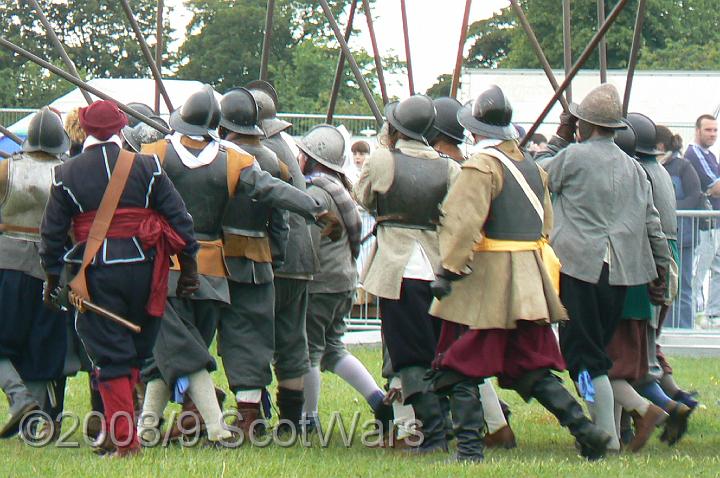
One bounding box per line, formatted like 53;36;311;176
0;0;172;106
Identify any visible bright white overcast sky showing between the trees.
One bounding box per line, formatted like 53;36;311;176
165;0;509;97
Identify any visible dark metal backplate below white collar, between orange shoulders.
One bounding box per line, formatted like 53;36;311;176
163;144;229;240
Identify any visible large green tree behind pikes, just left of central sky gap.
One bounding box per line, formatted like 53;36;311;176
176;0;399;113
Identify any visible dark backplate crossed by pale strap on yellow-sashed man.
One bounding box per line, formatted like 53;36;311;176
484;148;545;241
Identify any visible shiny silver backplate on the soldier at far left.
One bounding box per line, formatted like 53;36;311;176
0;153;61;242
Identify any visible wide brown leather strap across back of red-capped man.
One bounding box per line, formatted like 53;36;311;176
69;149;135;300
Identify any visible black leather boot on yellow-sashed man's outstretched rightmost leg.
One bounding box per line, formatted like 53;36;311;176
531;372;611;460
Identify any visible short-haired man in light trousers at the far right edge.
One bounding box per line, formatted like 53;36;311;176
685;114;720;319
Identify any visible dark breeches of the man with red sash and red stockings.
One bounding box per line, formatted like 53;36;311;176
75;262;160;380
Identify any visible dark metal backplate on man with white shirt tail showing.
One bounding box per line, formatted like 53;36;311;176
377;151;452;230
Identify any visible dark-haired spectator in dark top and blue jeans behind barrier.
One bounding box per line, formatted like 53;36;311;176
656;126;705;329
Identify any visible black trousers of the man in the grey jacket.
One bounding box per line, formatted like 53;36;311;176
560;264;627;381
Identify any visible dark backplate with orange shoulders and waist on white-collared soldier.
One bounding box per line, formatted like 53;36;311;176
142;137;254;277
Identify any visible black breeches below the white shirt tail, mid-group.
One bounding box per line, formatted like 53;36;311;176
380;279;442;372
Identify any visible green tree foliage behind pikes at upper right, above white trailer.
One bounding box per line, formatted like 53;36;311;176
428;0;720;95
